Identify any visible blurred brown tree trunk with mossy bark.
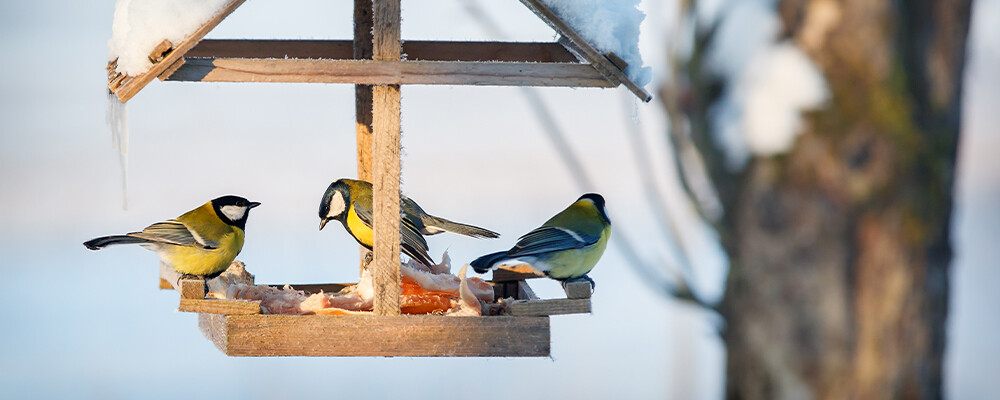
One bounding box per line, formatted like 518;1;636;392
668;0;971;399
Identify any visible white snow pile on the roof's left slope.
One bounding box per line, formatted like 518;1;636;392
108;0;229;76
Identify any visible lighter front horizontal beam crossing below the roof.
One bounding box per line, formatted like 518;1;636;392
167;58;615;87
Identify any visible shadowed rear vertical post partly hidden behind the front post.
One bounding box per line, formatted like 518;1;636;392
354;0;372;270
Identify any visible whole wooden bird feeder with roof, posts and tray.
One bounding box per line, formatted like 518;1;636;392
108;0;651;357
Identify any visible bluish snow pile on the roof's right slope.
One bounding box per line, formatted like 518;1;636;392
541;0;652;86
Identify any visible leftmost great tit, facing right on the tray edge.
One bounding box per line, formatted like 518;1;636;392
83;196;260;279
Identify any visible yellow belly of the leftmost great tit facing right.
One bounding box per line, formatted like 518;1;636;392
157;229;243;275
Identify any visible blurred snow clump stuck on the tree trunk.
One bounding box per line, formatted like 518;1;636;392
708;0;829;169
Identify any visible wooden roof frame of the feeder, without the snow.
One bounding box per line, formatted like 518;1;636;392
108;0;652;103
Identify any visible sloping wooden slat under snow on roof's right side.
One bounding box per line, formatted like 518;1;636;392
521;0;653;102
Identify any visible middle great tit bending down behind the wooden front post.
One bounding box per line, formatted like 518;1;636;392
319;178;500;266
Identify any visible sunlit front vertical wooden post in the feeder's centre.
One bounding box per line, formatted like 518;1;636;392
372;0;401;315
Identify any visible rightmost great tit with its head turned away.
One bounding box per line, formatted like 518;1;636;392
470;193;611;285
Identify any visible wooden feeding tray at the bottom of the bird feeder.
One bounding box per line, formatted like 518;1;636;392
160;266;590;357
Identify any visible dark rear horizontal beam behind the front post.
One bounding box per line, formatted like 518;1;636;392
184;39;579;63
